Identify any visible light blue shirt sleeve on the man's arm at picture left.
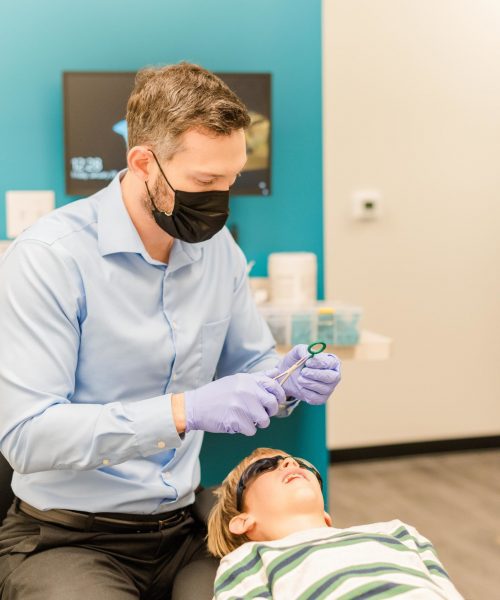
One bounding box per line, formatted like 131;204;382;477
0;240;181;473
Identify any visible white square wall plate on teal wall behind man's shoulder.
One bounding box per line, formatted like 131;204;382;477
5;190;55;238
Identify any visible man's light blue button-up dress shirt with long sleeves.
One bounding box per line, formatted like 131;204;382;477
0;173;278;514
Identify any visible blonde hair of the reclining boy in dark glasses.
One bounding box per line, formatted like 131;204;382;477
207;448;288;558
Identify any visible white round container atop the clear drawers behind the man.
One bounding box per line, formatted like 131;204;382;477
267;252;318;306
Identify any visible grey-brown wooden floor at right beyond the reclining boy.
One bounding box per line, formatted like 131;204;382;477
329;450;500;600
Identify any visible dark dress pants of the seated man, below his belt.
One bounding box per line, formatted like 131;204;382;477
0;505;218;600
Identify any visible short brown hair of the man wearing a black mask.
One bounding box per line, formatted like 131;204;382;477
127;62;250;159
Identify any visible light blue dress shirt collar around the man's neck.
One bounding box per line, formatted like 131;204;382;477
97;169;205;271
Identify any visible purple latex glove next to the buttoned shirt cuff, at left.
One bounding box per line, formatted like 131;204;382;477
184;373;286;435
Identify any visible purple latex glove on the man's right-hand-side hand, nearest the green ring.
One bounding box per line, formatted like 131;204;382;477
272;344;340;404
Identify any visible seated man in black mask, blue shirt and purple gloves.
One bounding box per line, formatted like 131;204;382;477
0;64;340;600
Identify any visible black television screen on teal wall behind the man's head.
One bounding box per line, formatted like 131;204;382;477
63;71;271;196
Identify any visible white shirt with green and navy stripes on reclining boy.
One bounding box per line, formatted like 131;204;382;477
214;520;463;600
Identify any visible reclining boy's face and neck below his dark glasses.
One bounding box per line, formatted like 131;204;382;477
230;454;331;540
